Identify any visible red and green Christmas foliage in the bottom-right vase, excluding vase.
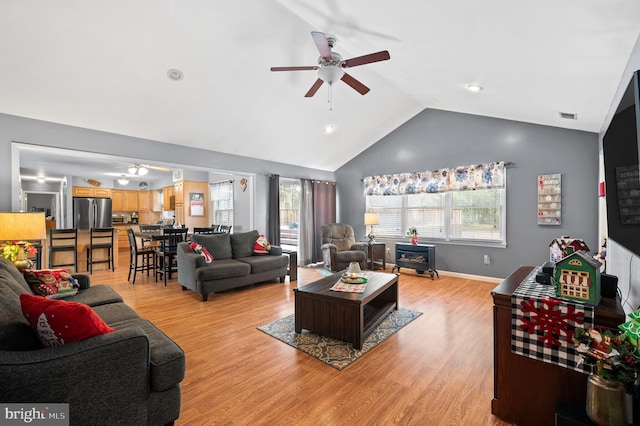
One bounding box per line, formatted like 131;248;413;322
573;326;640;389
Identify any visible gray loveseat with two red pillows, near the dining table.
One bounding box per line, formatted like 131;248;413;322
178;230;289;302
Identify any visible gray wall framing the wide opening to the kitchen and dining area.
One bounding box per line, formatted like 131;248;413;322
0;114;334;236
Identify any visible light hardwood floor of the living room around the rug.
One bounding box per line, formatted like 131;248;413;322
91;252;507;425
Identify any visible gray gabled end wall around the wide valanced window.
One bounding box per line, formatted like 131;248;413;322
336;109;599;278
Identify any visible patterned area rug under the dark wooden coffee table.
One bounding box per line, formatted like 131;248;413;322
257;308;422;370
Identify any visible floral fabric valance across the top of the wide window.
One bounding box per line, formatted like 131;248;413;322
364;161;505;195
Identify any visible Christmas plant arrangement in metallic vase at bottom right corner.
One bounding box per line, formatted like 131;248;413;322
573;327;640;425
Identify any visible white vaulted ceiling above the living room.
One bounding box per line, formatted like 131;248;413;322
0;0;640;176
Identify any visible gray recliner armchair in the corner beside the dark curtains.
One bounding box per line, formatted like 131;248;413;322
320;223;367;272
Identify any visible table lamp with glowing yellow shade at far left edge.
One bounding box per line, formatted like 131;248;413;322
0;212;47;269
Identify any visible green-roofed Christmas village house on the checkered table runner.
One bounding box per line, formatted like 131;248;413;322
553;251;602;306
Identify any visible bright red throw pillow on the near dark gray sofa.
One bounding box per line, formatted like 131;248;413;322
20;294;115;348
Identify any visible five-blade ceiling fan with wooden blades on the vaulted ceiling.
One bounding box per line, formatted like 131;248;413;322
271;31;391;98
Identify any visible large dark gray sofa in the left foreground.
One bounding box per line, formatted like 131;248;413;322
0;256;185;425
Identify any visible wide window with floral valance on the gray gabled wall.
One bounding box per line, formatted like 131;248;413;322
364;162;506;246
